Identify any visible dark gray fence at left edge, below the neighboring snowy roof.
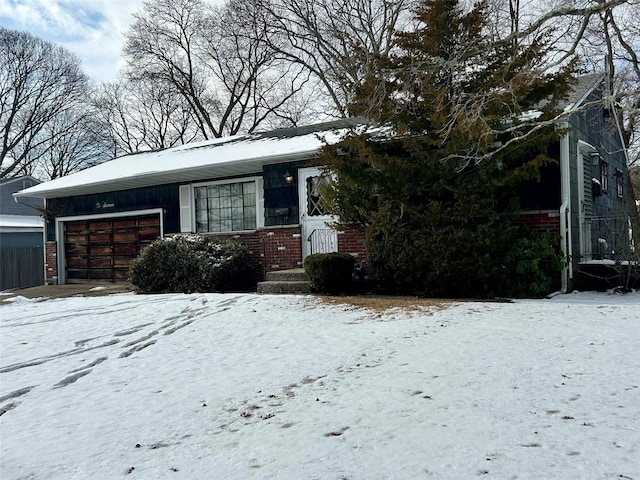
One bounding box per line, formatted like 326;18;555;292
0;247;44;291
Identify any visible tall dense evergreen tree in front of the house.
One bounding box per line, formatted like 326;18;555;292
320;0;573;296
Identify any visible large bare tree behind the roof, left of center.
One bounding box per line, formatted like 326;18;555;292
124;0;306;139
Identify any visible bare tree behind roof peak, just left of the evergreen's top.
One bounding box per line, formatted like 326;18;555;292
254;0;417;117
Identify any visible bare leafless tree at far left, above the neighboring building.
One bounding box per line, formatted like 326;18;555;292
0;27;89;178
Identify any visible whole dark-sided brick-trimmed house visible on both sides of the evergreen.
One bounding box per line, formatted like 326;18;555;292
17;76;628;291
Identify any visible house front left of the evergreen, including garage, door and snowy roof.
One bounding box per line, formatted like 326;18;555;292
16;121;364;284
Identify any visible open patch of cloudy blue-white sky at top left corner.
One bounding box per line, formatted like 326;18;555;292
0;0;149;81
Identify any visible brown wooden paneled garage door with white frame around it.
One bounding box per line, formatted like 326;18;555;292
64;214;160;283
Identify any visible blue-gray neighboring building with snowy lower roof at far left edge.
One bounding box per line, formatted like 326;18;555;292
0;176;44;290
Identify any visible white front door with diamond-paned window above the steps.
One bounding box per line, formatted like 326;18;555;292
298;167;338;260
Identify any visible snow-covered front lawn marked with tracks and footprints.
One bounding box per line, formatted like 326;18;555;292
0;294;640;480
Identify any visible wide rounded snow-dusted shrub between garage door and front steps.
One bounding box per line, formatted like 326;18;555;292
129;234;252;293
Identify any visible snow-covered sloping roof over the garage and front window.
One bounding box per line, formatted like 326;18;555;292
15;121;355;202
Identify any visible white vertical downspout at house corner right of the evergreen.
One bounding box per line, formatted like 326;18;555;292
558;122;573;293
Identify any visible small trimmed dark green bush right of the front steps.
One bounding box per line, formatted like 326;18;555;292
304;252;355;295
